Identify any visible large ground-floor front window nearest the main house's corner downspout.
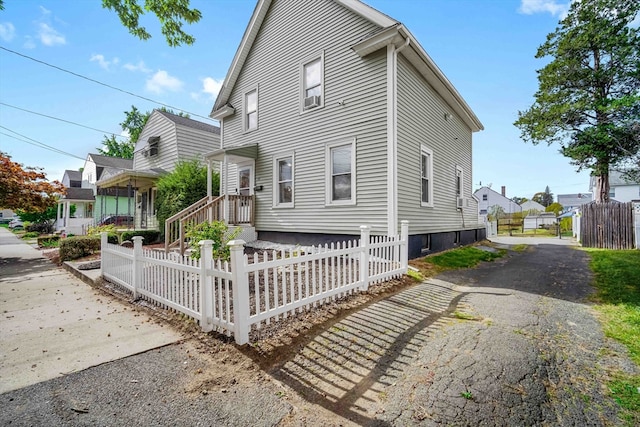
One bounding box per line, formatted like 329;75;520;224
326;138;356;205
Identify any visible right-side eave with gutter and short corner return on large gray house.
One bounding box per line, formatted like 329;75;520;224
352;24;484;132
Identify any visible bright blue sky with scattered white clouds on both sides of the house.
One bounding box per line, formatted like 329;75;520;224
0;0;600;198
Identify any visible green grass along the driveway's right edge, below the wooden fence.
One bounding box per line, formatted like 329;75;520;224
586;249;640;425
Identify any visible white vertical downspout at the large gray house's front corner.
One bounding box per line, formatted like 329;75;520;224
387;37;411;236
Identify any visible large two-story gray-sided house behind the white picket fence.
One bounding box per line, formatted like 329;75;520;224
209;0;485;257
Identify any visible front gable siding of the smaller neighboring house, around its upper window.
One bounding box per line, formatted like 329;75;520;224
133;112;178;172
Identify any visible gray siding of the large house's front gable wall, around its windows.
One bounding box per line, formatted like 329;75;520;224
224;0;387;234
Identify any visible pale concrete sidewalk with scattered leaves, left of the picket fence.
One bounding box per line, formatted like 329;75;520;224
0;228;182;393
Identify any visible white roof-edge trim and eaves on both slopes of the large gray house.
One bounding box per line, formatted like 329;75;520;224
211;0;484;132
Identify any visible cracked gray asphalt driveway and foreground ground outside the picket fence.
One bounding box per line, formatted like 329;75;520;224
0;241;638;426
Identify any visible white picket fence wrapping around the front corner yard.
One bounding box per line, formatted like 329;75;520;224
101;221;409;344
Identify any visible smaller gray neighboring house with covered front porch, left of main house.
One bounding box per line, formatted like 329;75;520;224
97;110;220;229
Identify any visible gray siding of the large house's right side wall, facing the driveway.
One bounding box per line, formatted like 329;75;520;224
398;54;478;234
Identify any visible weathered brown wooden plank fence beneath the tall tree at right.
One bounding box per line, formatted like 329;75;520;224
580;202;635;249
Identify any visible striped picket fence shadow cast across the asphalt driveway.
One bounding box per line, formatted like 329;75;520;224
242;281;508;425
